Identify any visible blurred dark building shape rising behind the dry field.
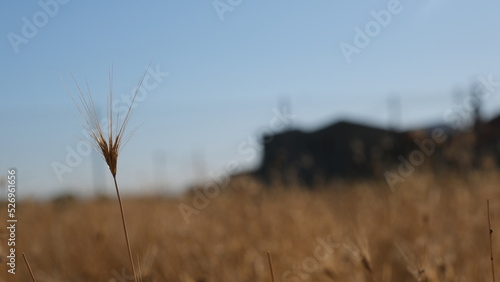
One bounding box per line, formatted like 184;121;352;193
248;100;500;187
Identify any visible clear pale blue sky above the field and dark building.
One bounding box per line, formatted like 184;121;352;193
0;0;500;197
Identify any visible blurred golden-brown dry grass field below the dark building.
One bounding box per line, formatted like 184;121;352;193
0;172;500;282
